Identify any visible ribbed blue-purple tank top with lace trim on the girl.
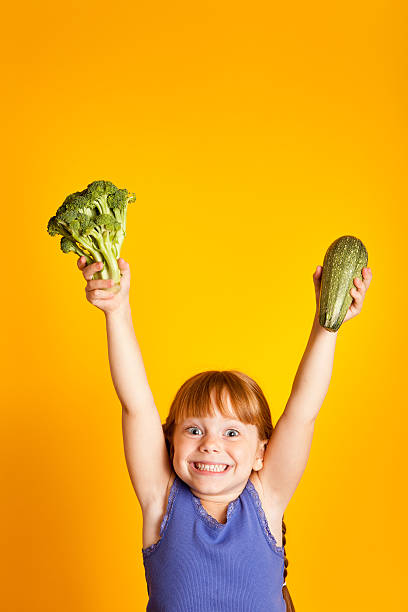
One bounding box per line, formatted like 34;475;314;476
142;474;286;612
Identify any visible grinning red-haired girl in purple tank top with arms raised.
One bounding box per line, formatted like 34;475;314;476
78;257;372;612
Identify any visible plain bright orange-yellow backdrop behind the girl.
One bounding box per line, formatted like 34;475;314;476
0;0;408;612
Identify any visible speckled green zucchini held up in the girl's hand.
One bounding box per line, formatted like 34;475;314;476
319;236;368;332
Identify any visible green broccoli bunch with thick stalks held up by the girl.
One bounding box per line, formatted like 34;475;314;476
47;181;136;284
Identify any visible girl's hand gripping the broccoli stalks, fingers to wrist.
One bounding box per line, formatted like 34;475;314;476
77;257;130;313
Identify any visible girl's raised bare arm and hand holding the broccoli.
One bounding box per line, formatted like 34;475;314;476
78;257;171;512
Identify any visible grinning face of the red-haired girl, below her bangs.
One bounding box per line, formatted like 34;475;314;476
173;396;267;495
